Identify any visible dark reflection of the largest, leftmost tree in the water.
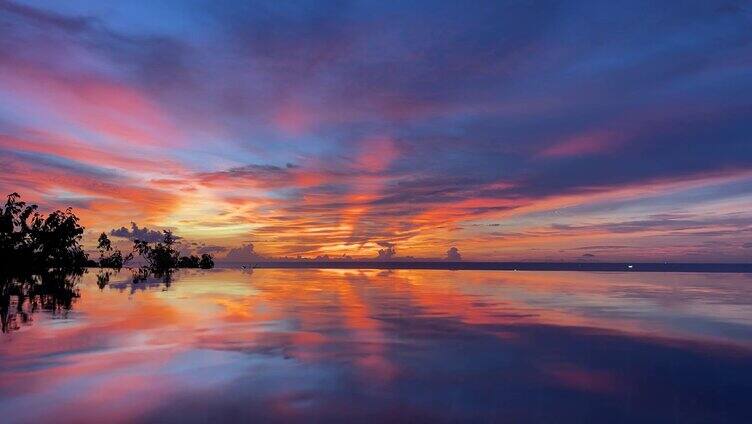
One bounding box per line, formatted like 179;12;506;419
0;271;83;333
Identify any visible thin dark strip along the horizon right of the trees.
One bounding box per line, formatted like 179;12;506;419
217;261;752;273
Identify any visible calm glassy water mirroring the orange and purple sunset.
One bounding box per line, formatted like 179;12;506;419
0;269;752;423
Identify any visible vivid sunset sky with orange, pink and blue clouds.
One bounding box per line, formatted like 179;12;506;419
0;0;752;262
